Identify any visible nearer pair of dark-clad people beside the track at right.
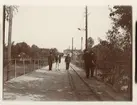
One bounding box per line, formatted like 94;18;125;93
83;50;96;78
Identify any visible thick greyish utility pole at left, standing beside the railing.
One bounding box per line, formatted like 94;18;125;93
7;6;13;80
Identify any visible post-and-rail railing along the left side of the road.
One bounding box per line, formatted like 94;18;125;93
3;58;48;82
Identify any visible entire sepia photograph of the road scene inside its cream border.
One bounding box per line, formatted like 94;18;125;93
2;5;133;102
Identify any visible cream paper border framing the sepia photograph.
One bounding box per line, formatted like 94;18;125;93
0;0;137;105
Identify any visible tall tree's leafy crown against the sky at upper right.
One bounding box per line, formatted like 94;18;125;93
108;6;132;49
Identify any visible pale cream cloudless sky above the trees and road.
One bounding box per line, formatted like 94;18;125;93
3;6;111;52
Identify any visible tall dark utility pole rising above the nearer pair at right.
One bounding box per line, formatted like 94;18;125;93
85;6;88;49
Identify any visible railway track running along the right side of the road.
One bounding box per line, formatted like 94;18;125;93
67;66;115;101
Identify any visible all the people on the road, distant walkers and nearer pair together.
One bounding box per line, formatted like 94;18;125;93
48;49;96;78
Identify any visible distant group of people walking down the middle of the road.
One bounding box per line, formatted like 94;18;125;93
48;52;71;70
